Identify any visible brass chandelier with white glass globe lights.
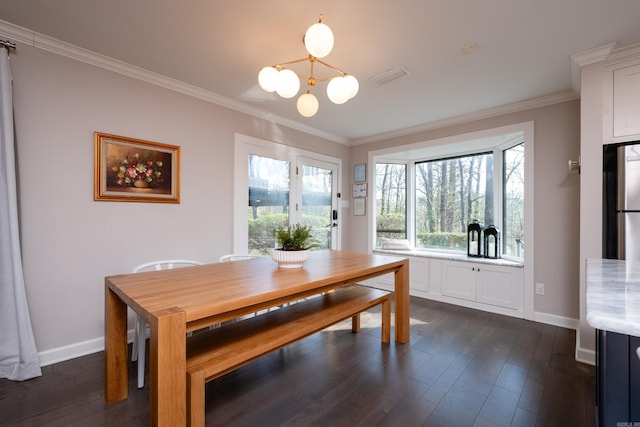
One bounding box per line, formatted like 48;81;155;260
258;15;360;117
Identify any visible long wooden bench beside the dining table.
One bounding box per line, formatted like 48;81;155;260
187;285;391;426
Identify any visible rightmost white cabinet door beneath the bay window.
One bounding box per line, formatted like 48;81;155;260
477;266;517;308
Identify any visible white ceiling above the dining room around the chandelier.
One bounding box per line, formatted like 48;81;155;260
0;0;640;144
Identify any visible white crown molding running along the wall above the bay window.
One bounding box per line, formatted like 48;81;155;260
351;90;580;146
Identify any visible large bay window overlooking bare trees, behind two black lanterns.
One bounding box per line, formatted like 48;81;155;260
371;126;533;261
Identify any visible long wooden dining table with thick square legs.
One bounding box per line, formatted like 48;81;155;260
105;250;409;427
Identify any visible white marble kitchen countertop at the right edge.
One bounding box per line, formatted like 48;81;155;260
587;259;640;337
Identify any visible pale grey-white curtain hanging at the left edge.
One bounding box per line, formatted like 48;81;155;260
0;48;42;381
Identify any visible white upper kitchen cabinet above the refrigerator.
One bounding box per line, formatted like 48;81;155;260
603;48;640;144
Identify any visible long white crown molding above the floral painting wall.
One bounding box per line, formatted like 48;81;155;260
0;20;349;145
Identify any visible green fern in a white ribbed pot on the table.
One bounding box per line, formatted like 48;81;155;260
271;224;318;268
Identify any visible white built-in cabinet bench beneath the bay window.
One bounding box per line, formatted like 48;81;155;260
367;249;524;318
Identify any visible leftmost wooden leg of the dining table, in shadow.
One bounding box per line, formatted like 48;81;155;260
104;284;129;403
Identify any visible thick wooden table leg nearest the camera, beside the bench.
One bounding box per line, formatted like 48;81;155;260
149;308;187;427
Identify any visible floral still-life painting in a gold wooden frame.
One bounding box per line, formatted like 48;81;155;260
93;132;180;203
